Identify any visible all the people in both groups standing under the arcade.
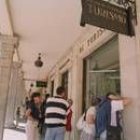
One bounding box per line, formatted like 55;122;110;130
23;86;131;140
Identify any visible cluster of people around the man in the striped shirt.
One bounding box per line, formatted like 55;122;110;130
26;86;73;140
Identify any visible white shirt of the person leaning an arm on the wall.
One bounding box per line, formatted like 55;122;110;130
111;100;124;126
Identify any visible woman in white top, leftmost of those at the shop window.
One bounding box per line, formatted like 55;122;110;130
80;99;99;140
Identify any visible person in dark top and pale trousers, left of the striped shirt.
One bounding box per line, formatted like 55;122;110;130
25;92;42;140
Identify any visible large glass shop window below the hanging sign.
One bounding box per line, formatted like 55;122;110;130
83;36;120;110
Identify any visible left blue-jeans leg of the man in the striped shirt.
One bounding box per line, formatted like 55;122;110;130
45;128;55;140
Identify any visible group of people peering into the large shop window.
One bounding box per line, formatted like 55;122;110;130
77;93;131;140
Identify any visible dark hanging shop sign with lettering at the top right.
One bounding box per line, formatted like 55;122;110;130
81;0;134;36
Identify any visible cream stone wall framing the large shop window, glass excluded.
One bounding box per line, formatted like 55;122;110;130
47;19;140;140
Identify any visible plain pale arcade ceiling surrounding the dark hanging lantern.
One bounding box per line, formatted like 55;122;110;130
0;0;83;88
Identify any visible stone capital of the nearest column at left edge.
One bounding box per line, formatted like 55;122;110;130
0;35;19;47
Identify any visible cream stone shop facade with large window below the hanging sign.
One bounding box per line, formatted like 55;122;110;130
48;22;140;140
